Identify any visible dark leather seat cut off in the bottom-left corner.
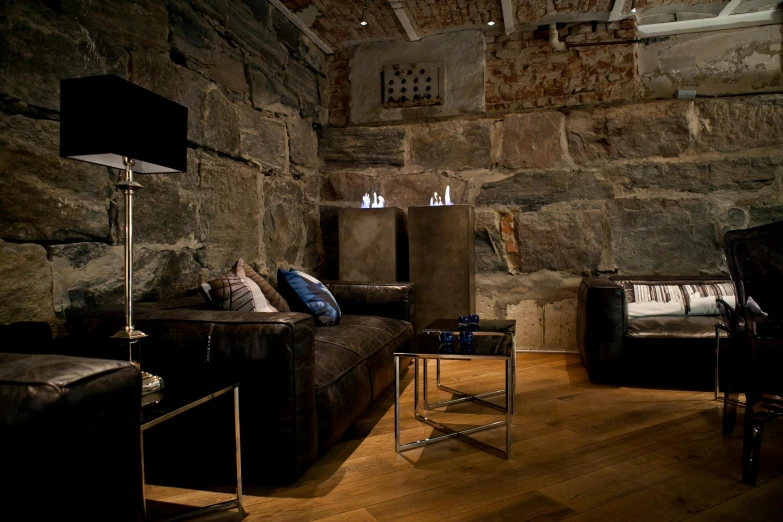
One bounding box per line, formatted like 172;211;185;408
0;353;143;522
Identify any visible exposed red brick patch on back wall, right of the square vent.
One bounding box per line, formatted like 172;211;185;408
485;20;638;112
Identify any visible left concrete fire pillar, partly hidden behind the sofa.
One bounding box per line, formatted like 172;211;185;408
337;207;408;283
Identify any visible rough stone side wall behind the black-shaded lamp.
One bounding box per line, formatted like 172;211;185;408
0;0;327;332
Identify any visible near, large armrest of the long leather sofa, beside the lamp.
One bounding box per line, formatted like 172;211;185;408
71;309;318;483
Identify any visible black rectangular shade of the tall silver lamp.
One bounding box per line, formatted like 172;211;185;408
60;75;188;174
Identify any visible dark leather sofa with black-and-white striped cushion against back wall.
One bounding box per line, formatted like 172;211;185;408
577;275;731;389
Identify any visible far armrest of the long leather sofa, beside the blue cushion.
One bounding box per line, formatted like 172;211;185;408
325;281;415;323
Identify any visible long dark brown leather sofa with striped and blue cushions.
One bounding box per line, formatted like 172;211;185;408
69;282;414;484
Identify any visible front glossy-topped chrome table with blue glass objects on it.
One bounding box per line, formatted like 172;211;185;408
394;332;516;459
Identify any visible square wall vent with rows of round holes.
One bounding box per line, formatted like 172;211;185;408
381;62;443;108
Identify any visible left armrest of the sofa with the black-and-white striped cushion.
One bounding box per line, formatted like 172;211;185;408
576;277;628;381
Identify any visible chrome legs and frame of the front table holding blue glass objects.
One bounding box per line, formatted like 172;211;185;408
394;351;516;459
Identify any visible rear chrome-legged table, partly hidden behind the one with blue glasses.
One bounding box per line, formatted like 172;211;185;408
422;319;517;413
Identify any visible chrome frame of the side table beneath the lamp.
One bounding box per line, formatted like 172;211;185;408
139;383;245;522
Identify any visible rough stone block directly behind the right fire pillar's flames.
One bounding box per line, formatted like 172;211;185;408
379;172;468;208
